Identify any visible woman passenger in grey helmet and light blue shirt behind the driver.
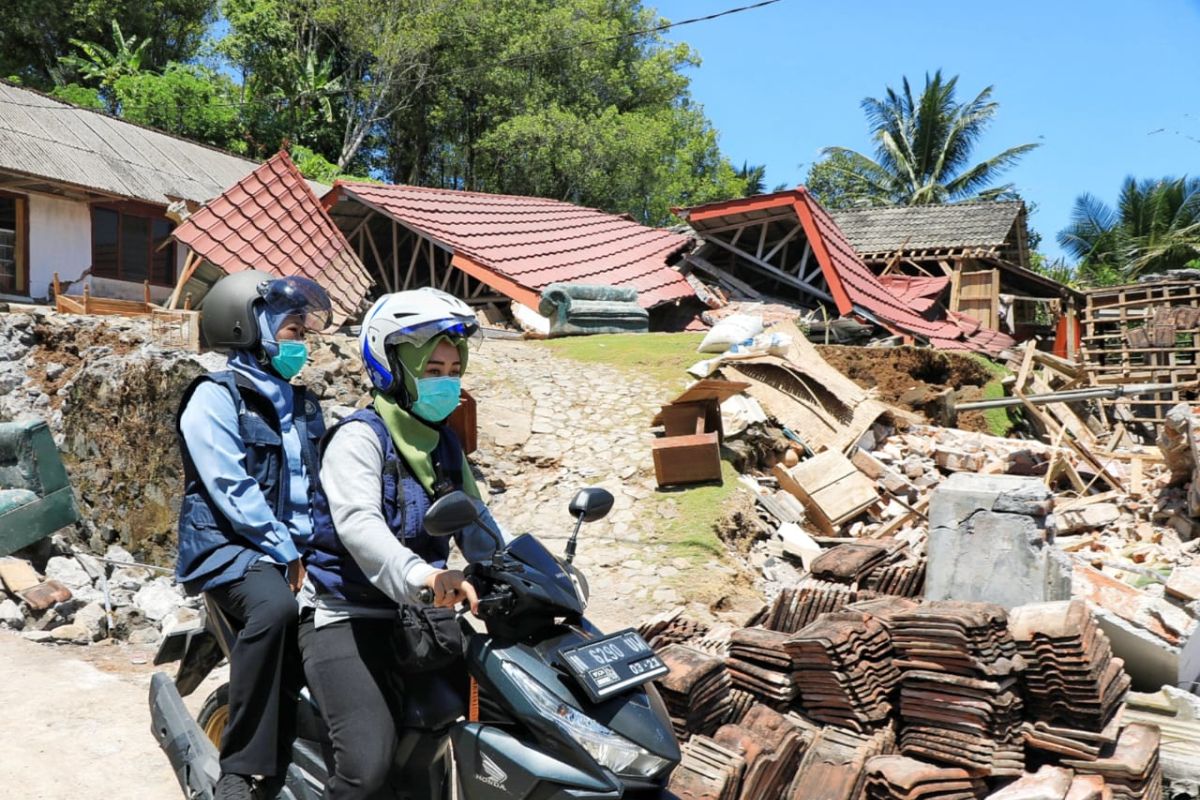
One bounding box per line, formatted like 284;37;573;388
175;271;330;800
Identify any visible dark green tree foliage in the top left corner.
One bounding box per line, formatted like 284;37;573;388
0;0;216;90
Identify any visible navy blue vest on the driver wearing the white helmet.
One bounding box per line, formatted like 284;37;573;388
304;408;463;608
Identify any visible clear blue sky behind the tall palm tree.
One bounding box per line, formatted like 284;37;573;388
647;0;1200;258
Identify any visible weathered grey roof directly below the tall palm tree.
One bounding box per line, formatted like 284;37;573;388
830;200;1024;253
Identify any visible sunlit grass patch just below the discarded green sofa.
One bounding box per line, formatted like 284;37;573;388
545;333;708;391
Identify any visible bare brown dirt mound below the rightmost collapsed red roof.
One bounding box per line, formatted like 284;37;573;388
817;344;994;431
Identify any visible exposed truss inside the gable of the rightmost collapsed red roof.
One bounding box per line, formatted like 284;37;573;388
689;209;833;306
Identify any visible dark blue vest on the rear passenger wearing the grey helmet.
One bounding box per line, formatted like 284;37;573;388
175;371;325;595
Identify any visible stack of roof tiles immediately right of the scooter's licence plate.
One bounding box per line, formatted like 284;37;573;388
658;644;733;739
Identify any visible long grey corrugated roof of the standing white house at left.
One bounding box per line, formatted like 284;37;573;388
0;83;265;205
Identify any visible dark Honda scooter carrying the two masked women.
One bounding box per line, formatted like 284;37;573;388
150;488;680;800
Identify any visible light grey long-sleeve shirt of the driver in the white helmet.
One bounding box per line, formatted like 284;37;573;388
300;421;509;627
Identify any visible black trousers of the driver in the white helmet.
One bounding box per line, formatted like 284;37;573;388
300;618;403;800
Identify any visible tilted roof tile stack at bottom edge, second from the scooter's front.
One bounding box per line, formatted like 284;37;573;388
713;704;811;800
